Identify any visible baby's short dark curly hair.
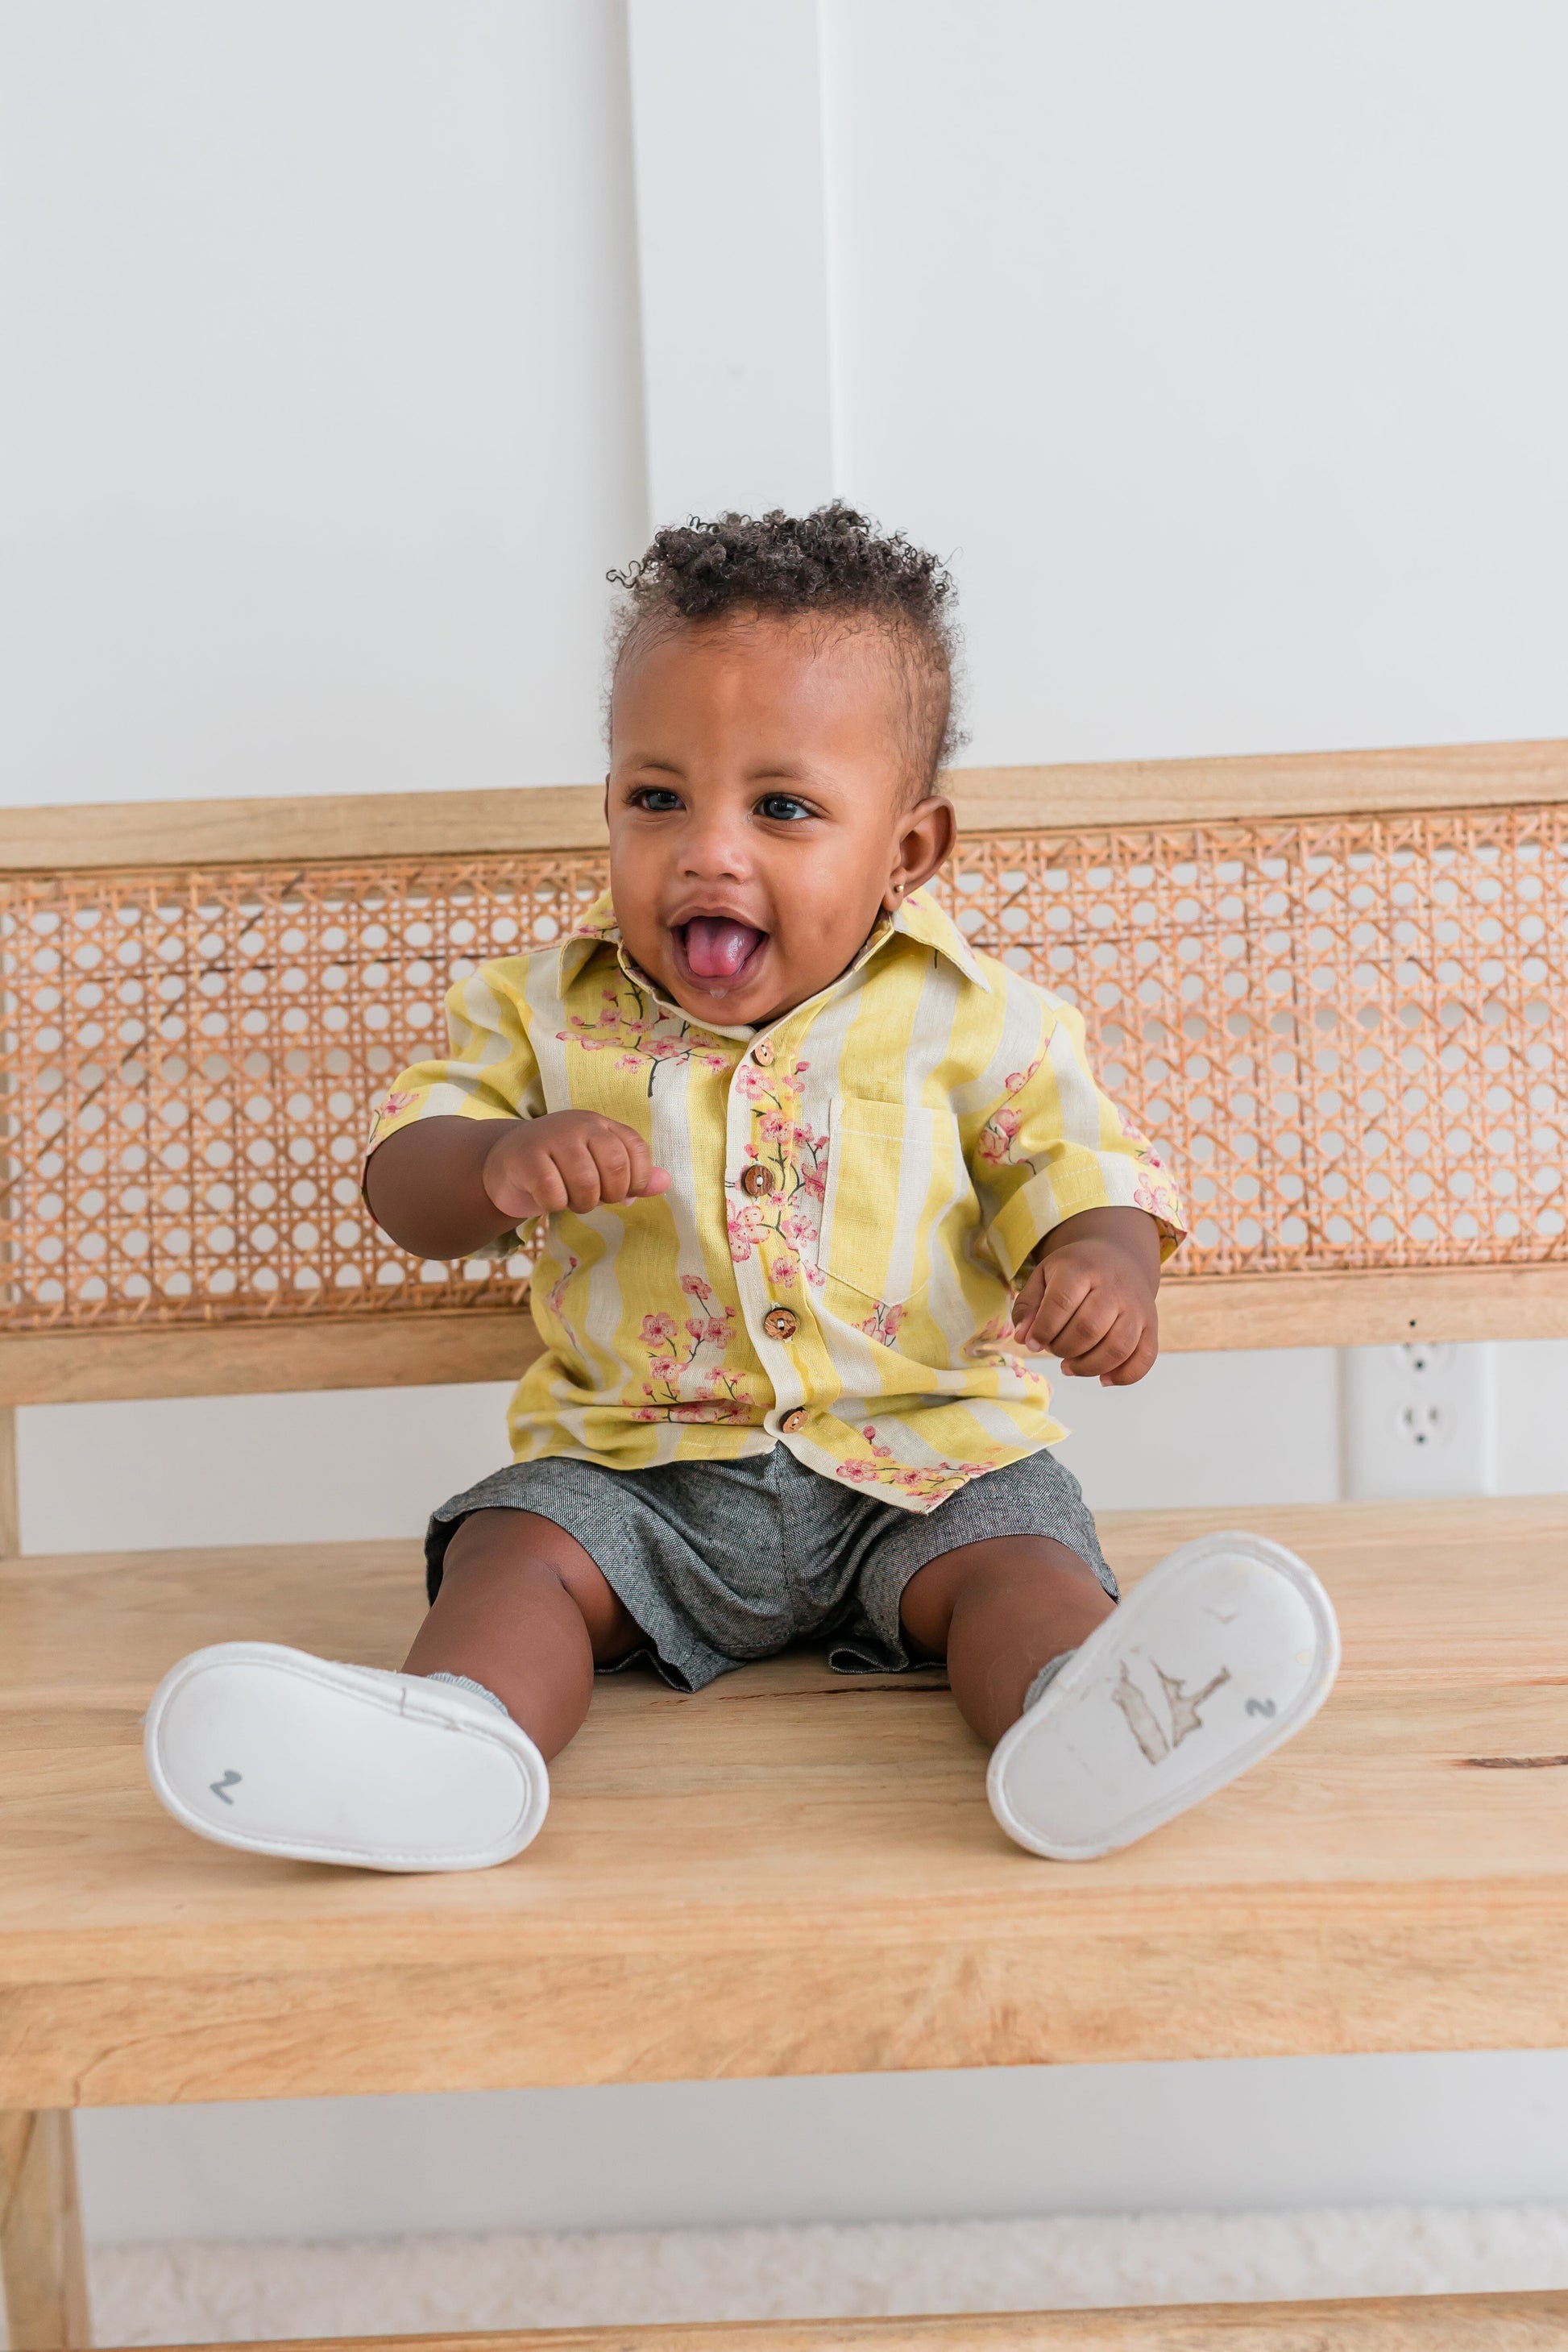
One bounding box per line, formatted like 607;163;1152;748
609;499;964;799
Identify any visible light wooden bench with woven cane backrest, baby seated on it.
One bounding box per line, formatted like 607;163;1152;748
0;745;1568;2352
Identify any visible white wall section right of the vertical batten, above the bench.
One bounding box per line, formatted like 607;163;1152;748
825;0;1568;762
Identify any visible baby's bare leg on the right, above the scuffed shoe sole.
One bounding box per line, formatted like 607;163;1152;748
900;1536;1117;1748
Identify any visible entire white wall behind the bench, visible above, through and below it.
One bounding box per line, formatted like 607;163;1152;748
0;0;1568;2234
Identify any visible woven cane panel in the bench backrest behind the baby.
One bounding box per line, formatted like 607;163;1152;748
0;807;1568;1329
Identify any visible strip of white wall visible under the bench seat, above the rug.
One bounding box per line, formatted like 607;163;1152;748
77;2051;1568;2244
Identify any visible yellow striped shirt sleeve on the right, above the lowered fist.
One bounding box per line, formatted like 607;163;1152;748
971;1000;1187;1282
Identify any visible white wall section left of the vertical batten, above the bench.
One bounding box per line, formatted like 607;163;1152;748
0;0;646;804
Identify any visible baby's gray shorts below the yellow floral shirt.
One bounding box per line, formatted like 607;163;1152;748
425;1446;1117;1691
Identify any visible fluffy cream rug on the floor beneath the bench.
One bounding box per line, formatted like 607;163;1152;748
92;2206;1568;2345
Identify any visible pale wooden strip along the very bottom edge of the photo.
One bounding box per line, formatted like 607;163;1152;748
152;2293;1568;2352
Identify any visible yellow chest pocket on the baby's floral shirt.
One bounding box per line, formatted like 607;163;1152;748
818;1093;935;1305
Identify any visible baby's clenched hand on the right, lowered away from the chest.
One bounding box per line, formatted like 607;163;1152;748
1013;1209;1159;1388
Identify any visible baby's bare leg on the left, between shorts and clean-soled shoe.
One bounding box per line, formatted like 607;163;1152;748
404;1510;641;1759
